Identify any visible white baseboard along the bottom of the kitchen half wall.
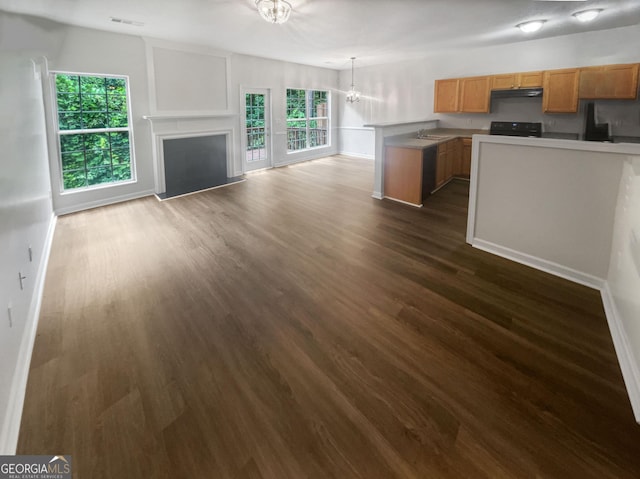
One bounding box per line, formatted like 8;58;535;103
471;238;604;290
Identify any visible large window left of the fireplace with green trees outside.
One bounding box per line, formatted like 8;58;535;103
55;73;134;190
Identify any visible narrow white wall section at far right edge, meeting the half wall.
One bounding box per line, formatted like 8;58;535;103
603;156;640;423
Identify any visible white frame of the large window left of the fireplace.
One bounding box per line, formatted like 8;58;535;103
49;70;138;195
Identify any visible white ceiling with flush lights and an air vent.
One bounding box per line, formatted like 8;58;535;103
0;0;640;69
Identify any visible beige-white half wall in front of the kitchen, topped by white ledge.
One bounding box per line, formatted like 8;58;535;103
468;136;624;288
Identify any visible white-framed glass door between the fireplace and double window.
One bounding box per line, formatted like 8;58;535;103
243;89;272;172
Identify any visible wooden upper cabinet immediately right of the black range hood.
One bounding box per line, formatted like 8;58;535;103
542;68;580;113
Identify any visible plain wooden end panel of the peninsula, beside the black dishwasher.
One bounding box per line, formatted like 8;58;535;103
384;146;422;205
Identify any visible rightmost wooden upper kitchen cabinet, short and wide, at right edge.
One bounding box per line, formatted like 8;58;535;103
579;63;640;100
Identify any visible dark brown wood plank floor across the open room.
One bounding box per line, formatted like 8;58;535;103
18;156;640;479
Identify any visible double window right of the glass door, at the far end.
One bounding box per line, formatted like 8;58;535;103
287;89;329;152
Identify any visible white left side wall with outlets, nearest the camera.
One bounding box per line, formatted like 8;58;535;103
0;52;55;454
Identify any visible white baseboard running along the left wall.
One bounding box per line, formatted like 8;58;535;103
0;214;57;455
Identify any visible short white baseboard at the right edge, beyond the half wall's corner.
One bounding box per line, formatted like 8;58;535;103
600;281;640;424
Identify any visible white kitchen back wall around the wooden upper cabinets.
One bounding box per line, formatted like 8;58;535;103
340;25;640;154
